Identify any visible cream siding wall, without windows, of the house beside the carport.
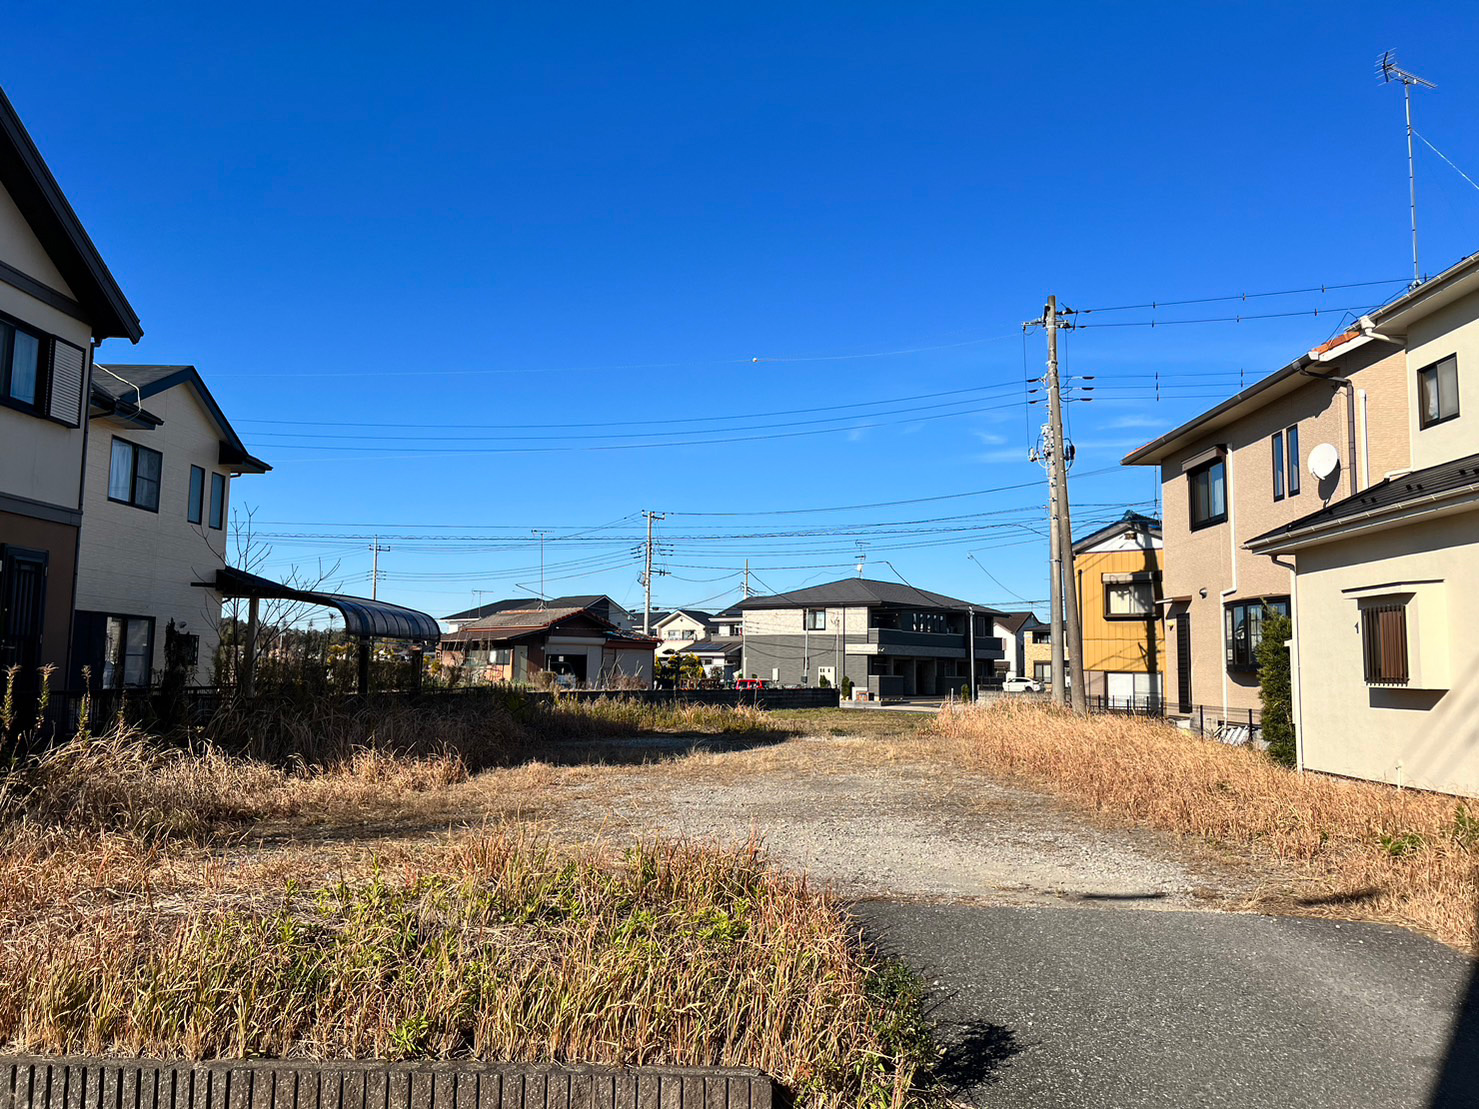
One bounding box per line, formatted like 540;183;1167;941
77;384;241;683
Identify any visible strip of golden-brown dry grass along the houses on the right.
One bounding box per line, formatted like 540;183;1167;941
935;702;1479;954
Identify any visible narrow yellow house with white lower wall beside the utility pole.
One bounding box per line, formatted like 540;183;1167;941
1074;512;1165;708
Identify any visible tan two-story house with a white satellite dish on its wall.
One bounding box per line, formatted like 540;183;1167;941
1124;304;1411;726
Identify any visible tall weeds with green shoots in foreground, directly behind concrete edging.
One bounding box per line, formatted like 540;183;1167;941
0;828;932;1109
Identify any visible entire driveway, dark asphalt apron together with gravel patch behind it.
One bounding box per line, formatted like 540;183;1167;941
532;735;1479;1109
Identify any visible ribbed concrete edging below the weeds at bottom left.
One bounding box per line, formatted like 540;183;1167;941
0;1056;778;1109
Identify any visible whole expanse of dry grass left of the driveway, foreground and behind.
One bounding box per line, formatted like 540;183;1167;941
0;729;930;1109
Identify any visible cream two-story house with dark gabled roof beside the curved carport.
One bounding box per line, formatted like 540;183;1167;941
70;362;271;689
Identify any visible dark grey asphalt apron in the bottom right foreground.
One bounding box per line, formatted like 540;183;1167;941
855;902;1479;1109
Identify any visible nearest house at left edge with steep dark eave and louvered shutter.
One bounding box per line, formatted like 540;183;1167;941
0;92;143;686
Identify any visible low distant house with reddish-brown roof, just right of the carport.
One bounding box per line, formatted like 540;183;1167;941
441;606;657;689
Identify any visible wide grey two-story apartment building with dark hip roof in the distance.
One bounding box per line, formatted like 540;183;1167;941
740;578;1006;698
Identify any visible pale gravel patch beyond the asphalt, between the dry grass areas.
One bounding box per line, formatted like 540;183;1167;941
558;738;1260;909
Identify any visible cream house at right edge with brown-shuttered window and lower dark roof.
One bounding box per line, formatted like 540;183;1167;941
1247;254;1479;796
